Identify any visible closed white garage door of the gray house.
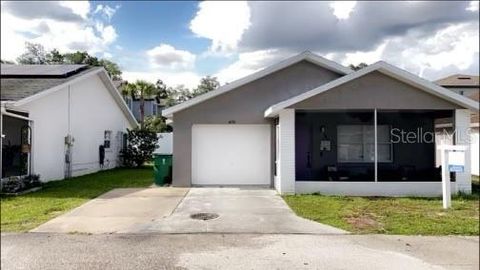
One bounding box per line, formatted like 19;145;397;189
192;125;271;185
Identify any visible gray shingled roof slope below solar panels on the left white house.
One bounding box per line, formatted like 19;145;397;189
0;65;102;101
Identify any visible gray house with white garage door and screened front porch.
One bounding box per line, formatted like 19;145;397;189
162;52;479;196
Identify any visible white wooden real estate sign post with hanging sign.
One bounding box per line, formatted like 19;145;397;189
438;145;466;209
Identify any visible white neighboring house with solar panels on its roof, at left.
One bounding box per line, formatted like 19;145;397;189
1;65;137;181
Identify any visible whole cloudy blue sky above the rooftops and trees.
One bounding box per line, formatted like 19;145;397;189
1;1;479;87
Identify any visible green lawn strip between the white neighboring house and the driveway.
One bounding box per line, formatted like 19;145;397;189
0;167;153;232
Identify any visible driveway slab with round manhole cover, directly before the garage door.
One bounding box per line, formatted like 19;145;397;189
141;187;346;234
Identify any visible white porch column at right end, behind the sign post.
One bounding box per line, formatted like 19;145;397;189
455;109;472;194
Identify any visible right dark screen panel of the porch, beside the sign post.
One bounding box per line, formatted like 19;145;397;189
377;110;451;182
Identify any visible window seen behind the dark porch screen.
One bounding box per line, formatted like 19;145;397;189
337;125;392;163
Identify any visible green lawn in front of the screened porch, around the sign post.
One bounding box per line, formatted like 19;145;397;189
283;186;479;235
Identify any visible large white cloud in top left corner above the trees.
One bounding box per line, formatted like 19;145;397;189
1;1;117;60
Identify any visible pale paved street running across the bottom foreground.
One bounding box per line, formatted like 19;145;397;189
1;233;479;270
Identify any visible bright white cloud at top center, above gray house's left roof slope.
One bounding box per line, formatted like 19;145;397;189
190;1;250;53
